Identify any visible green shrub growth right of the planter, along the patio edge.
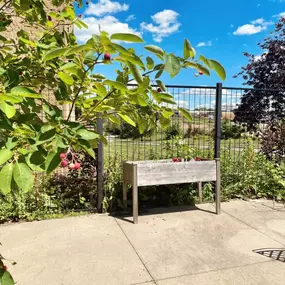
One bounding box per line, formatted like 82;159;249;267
221;140;285;200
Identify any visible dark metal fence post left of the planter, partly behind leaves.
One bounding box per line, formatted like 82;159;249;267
96;115;104;213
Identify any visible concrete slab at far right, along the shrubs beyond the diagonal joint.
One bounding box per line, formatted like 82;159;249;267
222;200;285;245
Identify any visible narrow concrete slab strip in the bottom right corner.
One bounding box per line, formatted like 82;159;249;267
157;261;285;285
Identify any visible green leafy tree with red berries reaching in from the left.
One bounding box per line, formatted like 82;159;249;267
0;0;226;285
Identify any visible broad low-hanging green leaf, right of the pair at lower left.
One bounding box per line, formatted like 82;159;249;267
13;162;34;192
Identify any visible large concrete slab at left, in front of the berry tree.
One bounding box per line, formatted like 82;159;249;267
0;215;152;285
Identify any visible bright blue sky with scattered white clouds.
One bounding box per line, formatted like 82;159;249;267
76;0;285;87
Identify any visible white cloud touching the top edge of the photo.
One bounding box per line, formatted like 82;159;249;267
84;0;129;16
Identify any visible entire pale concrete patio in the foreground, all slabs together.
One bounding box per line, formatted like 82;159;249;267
0;201;285;285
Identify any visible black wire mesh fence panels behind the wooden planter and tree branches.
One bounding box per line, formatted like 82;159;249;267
35;82;285;209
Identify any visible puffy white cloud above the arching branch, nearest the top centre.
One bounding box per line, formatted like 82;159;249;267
141;10;181;42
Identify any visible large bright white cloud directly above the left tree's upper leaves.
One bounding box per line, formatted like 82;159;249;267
75;15;140;42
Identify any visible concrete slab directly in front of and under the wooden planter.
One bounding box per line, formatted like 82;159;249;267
118;205;280;284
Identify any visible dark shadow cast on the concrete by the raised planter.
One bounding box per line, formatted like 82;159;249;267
110;206;216;223
